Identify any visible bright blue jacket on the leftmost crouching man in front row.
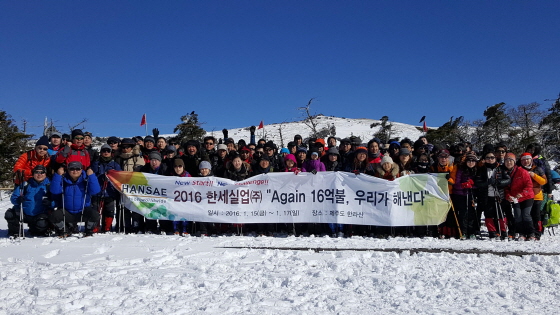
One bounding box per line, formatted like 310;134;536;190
10;178;53;216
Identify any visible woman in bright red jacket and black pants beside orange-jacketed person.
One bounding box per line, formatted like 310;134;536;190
504;153;536;240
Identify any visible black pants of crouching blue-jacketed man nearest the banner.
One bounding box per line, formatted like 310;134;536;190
49;207;99;234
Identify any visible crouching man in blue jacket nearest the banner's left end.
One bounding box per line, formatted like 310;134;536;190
50;162;101;236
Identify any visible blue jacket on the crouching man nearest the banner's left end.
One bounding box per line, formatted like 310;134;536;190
51;171;101;214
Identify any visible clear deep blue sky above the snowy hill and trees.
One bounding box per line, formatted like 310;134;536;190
0;0;560;136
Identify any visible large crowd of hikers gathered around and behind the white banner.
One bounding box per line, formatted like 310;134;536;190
5;126;558;240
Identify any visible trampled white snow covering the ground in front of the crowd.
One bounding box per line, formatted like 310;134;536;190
0;188;560;314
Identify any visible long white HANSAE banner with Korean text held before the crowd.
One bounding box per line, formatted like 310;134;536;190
108;171;450;226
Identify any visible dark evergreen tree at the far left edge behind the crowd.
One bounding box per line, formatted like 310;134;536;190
0;110;31;187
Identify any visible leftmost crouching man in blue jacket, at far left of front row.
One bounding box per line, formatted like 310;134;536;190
4;165;52;237
